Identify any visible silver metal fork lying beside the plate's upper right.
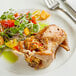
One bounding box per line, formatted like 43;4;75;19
44;0;76;23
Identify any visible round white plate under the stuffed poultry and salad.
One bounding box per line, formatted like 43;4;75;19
0;9;76;76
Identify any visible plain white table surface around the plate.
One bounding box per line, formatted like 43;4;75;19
0;0;76;76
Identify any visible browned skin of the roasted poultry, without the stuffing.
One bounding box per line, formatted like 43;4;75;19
25;25;67;68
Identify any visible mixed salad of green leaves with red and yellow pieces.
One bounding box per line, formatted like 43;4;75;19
0;9;50;62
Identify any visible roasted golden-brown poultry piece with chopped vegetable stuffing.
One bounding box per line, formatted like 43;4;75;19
24;25;69;69
